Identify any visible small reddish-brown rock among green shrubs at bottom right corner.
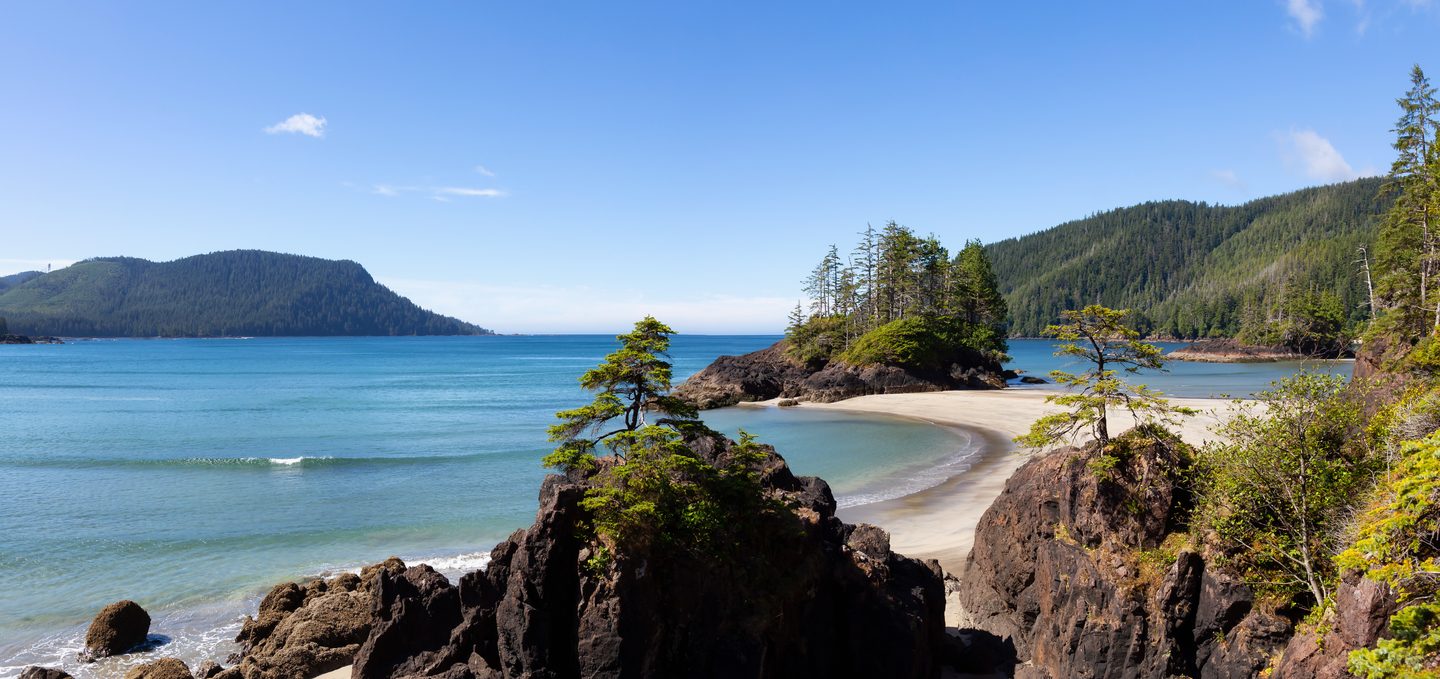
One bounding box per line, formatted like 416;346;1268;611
1274;573;1400;679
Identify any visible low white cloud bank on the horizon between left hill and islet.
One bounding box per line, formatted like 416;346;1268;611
383;279;795;334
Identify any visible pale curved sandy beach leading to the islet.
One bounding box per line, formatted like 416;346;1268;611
817;390;1233;575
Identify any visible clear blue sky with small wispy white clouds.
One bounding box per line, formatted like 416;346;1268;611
0;0;1440;332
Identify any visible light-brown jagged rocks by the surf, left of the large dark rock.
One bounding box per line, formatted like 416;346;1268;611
215;558;405;679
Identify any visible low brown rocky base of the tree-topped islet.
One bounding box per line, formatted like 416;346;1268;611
675;341;1005;409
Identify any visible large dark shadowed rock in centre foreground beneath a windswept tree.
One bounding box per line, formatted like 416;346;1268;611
354;439;945;679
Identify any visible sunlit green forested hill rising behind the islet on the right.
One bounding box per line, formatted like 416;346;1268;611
986;177;1388;338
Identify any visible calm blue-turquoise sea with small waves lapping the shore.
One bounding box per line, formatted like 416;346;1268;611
0;335;1349;678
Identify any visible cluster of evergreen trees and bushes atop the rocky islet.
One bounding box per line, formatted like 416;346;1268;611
786;222;1007;370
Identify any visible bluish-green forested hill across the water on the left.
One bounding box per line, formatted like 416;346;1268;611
0;250;491;337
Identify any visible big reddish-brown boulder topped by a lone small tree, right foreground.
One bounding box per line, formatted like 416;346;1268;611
959;440;1292;678
